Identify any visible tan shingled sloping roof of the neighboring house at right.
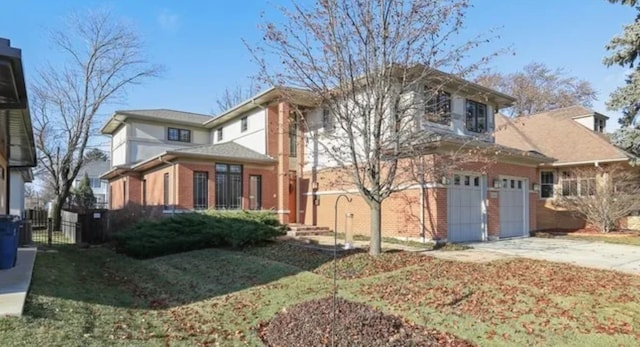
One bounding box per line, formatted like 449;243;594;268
495;111;631;166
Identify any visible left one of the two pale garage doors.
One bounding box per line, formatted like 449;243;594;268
447;174;484;242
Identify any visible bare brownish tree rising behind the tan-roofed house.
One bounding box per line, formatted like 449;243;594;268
476;63;596;117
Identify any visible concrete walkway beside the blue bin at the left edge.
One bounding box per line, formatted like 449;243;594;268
0;248;37;317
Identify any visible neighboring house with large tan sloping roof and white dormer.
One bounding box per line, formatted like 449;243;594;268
495;106;633;230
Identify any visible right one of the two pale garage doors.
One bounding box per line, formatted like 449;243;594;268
500;178;529;238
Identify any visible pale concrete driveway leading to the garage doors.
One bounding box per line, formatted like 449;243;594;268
469;237;640;275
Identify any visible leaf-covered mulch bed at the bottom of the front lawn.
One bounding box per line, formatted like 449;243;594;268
258;297;474;347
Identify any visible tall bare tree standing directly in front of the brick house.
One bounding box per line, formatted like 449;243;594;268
250;0;500;255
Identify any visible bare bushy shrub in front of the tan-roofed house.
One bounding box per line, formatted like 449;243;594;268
556;165;640;233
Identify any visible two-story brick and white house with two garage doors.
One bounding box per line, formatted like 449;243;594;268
102;73;551;242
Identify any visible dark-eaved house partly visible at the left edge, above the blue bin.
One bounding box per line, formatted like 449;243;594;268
0;38;36;215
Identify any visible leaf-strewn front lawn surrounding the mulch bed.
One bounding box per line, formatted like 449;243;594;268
0;243;640;346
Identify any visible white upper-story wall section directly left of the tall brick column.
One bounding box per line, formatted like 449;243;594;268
211;109;267;154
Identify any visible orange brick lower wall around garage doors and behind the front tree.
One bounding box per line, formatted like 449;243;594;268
300;158;538;239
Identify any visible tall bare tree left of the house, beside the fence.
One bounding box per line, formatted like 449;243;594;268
31;11;161;228
